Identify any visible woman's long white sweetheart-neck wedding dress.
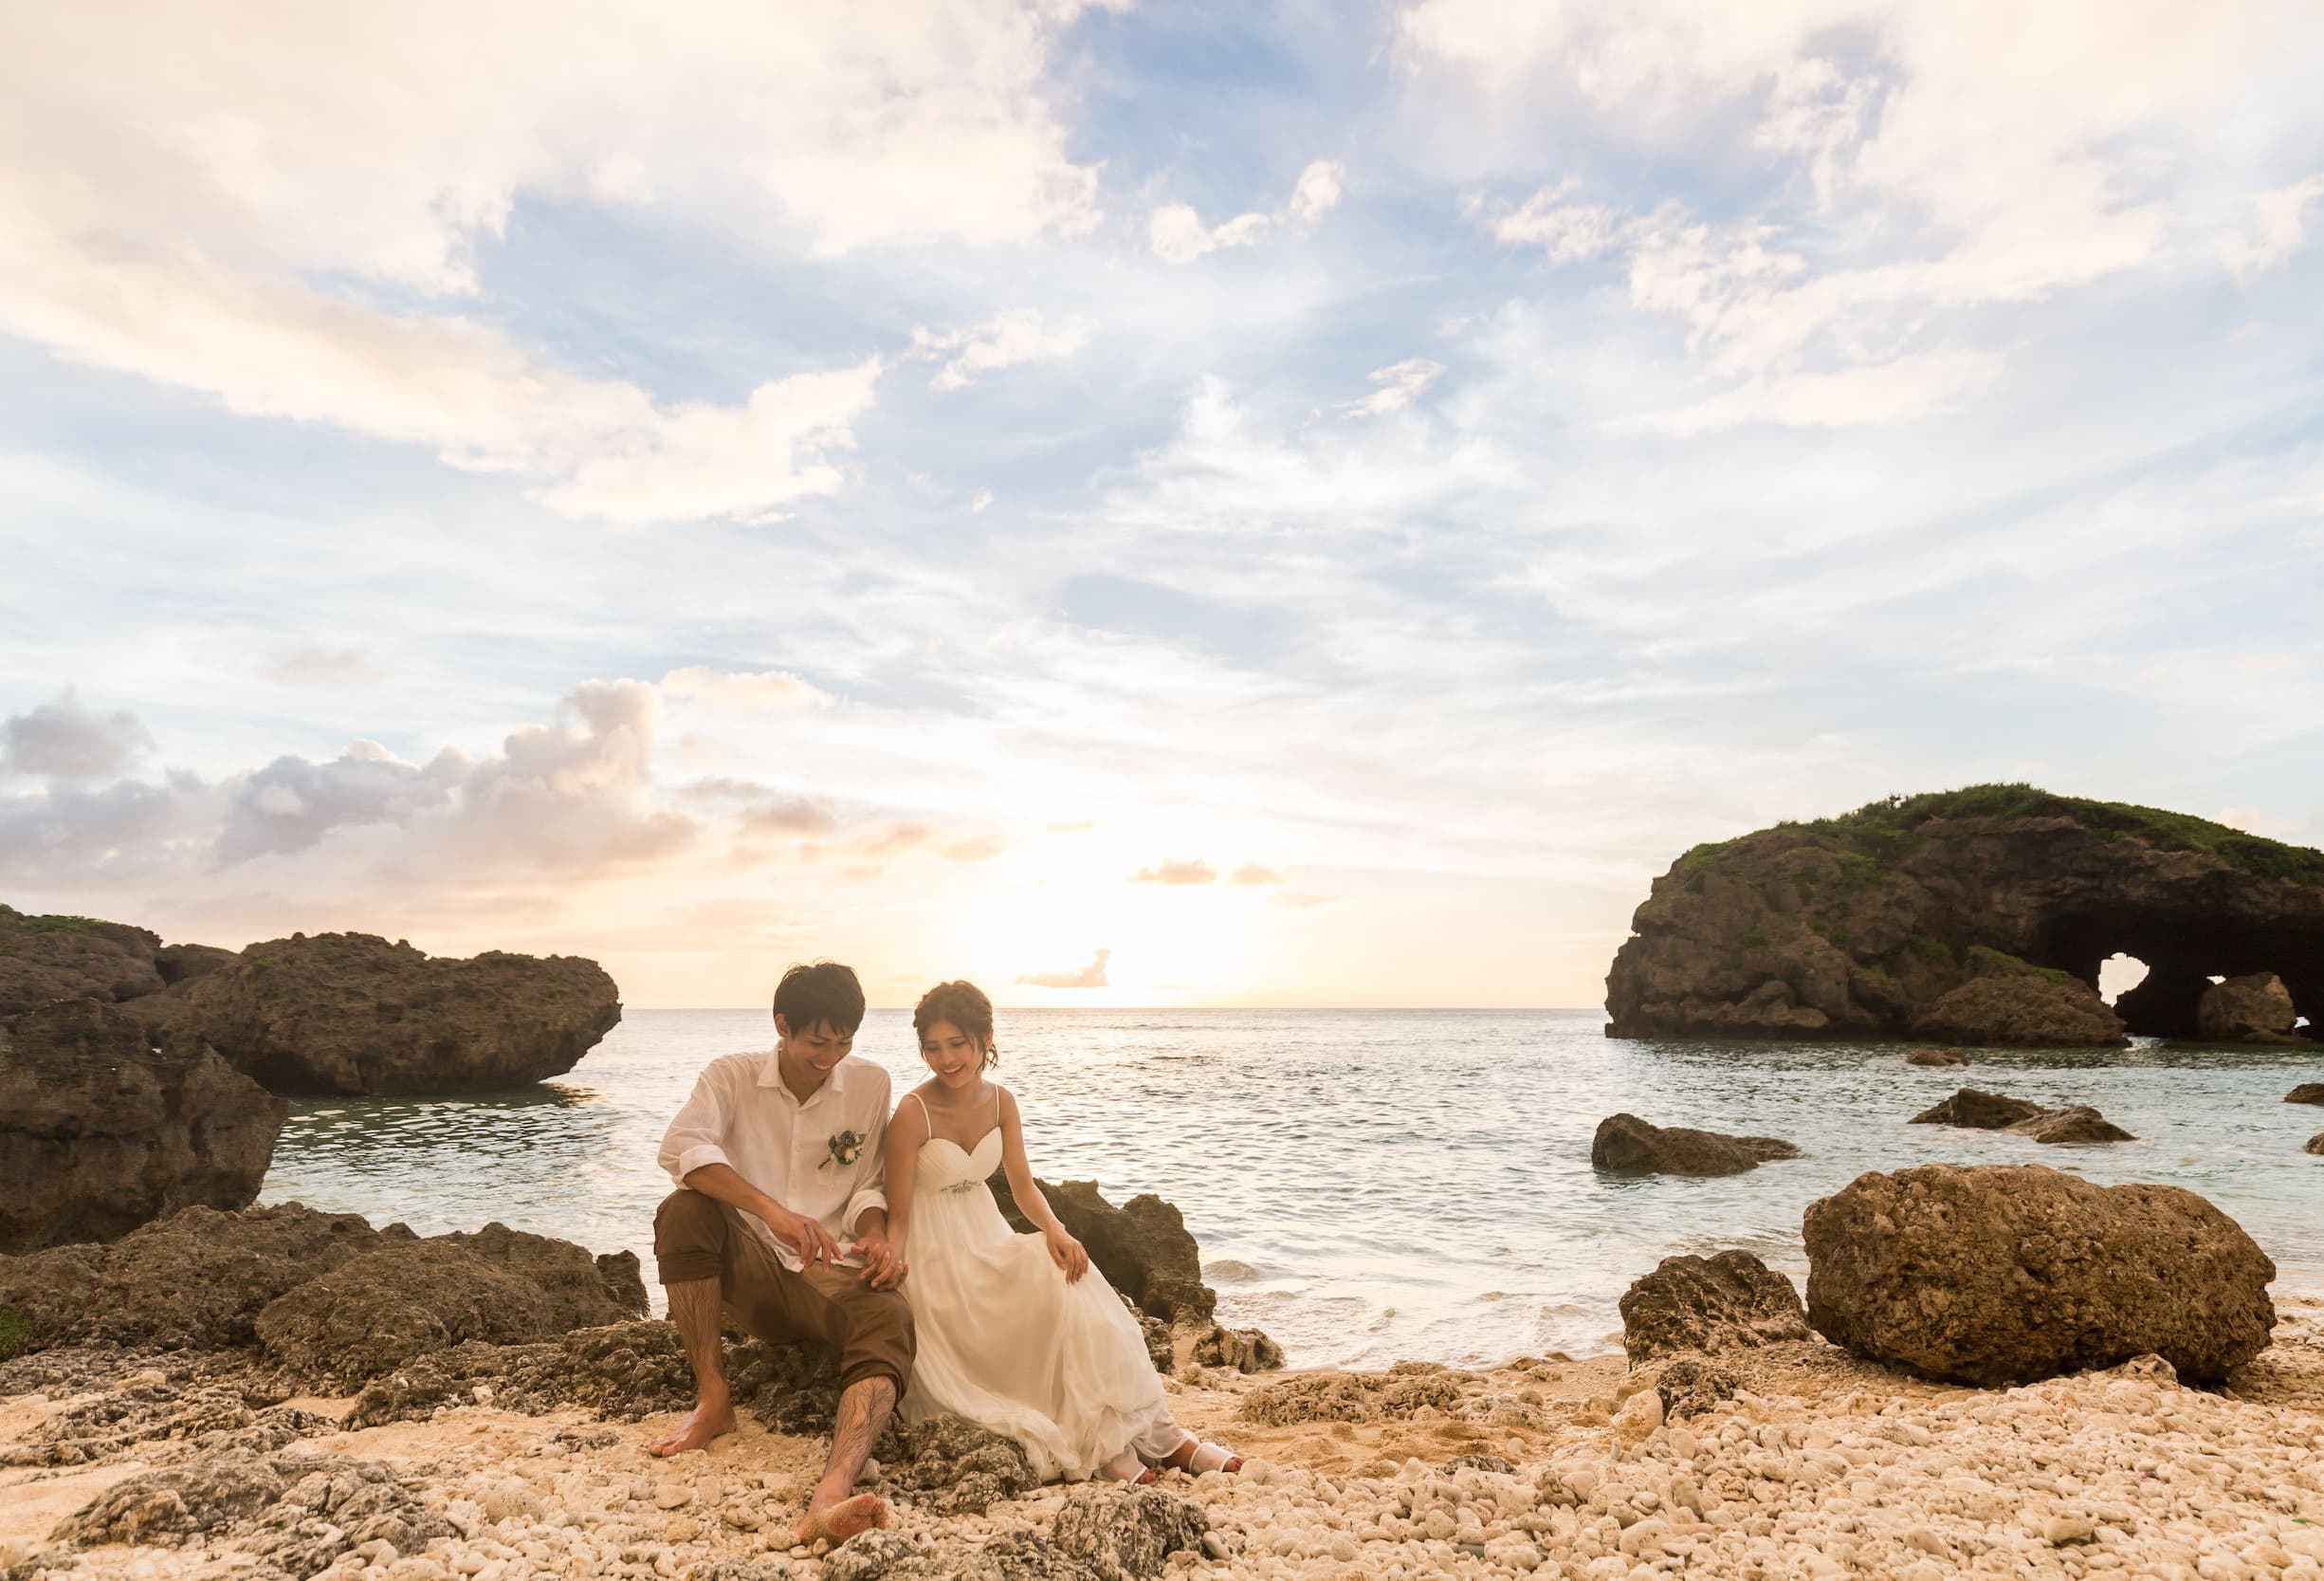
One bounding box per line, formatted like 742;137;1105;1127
902;1097;1185;1479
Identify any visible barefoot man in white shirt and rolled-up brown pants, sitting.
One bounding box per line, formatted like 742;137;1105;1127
649;960;913;1544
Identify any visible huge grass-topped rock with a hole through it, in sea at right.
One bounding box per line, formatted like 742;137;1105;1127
1606;786;2324;1044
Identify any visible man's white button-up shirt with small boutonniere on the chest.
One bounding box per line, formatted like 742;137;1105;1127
660;1049;888;1272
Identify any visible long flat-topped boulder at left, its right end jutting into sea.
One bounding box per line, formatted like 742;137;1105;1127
156;932;620;1095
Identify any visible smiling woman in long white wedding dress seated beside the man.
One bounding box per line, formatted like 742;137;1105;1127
886;984;1243;1481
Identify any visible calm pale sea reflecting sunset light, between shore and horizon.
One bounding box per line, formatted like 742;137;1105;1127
265;1011;2324;1367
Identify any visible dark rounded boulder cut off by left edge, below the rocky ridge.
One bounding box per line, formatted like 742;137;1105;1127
0;1000;288;1253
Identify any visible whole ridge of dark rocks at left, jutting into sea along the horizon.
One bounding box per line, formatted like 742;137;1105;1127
0;907;620;1095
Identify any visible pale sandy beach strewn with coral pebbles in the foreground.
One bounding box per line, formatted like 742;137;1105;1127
0;1299;2324;1581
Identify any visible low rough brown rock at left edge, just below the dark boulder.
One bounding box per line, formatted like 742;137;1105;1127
0;1202;394;1351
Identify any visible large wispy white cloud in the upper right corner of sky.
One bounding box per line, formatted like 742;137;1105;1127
1400;0;2313;428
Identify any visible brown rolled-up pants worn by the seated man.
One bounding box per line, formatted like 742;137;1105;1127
653;1186;913;1400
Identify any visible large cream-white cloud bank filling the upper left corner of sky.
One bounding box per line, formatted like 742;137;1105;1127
0;0;1099;524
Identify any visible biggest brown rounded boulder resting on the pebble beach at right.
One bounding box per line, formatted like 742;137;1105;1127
1803;1165;2276;1386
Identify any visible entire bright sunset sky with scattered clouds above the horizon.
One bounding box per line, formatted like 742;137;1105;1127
0;0;2324;1006
